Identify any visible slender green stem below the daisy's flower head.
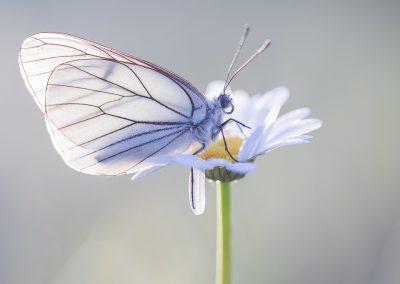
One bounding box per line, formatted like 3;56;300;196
215;181;231;284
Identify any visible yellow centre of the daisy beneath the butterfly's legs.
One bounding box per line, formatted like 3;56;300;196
197;136;243;162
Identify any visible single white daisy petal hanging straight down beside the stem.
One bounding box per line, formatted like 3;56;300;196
189;168;206;215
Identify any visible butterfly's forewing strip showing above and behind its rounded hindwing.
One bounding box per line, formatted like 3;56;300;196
19;33;206;111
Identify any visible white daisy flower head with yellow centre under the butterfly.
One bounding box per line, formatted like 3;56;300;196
132;81;321;215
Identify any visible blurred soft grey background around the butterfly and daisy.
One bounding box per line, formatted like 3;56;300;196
0;0;400;284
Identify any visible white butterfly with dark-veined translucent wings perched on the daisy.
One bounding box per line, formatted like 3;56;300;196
19;28;269;214
